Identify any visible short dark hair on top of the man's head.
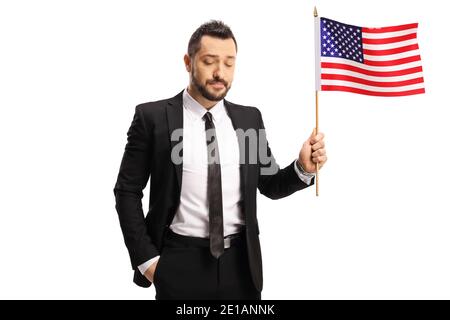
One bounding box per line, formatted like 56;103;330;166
188;20;237;58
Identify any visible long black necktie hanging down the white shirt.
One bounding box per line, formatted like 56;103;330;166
203;112;224;258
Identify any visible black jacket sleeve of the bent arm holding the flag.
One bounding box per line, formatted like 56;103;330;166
257;109;314;199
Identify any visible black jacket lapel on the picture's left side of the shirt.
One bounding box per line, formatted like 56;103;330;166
166;90;184;192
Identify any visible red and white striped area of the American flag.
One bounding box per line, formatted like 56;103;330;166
320;23;425;97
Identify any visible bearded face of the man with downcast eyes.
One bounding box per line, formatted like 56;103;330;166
187;36;236;101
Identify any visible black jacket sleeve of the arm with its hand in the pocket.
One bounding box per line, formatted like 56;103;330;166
114;106;159;270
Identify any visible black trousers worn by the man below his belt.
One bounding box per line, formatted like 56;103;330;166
153;228;261;300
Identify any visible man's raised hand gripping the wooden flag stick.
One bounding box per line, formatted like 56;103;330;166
297;129;327;173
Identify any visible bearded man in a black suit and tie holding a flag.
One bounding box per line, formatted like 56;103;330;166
114;21;327;299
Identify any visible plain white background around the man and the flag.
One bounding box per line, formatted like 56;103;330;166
0;0;450;299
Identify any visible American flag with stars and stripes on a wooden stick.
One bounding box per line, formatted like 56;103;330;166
316;18;425;97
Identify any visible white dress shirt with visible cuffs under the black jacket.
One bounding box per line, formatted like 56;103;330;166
138;89;314;274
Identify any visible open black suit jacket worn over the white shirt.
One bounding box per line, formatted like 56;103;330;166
114;91;314;291
